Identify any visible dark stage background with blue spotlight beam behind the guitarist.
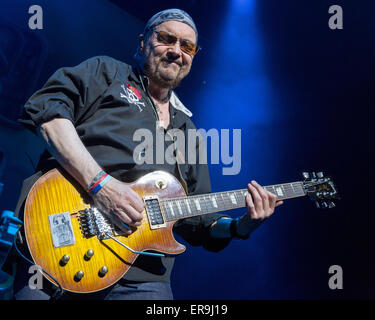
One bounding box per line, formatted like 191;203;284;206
0;0;375;299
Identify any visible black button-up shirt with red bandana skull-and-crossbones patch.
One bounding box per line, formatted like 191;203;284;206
21;56;234;281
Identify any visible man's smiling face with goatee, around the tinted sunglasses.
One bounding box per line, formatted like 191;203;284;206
144;21;196;89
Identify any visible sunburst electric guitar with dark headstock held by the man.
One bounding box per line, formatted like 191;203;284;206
24;169;339;293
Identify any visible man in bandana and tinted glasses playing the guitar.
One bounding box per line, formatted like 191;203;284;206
11;9;281;299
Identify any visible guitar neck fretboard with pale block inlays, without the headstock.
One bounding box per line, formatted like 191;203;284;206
160;181;306;221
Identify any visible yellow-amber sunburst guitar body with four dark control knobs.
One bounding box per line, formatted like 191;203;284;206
24;169;185;293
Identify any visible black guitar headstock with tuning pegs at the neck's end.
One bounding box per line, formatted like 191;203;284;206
302;172;340;209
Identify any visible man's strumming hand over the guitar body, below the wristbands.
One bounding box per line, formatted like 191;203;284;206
92;178;145;235
